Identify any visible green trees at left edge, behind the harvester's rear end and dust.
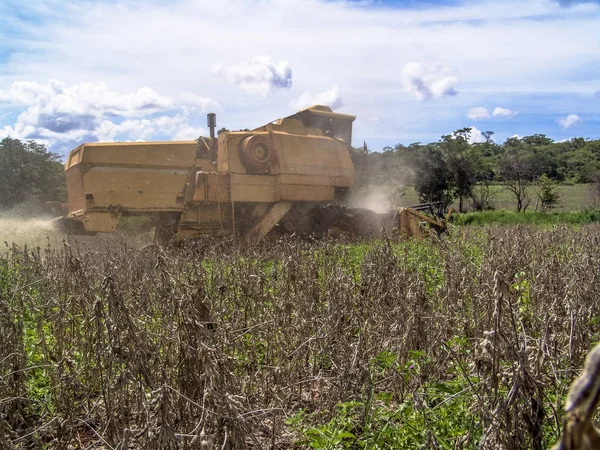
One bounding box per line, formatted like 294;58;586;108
0;137;66;210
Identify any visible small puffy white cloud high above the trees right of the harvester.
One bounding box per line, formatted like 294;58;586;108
402;62;458;101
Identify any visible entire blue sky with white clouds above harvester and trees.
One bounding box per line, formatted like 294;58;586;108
0;0;600;154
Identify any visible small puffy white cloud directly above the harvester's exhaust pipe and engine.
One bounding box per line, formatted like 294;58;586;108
210;56;292;97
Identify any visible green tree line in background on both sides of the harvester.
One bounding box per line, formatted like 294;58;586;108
0;128;600;211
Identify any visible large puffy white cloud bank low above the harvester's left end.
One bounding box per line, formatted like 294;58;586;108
0;80;220;150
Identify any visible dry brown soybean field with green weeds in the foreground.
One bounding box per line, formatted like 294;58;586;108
0;227;600;450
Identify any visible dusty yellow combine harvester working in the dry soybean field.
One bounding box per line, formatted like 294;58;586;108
50;105;446;243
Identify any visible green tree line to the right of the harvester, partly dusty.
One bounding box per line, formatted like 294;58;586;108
353;128;600;212
